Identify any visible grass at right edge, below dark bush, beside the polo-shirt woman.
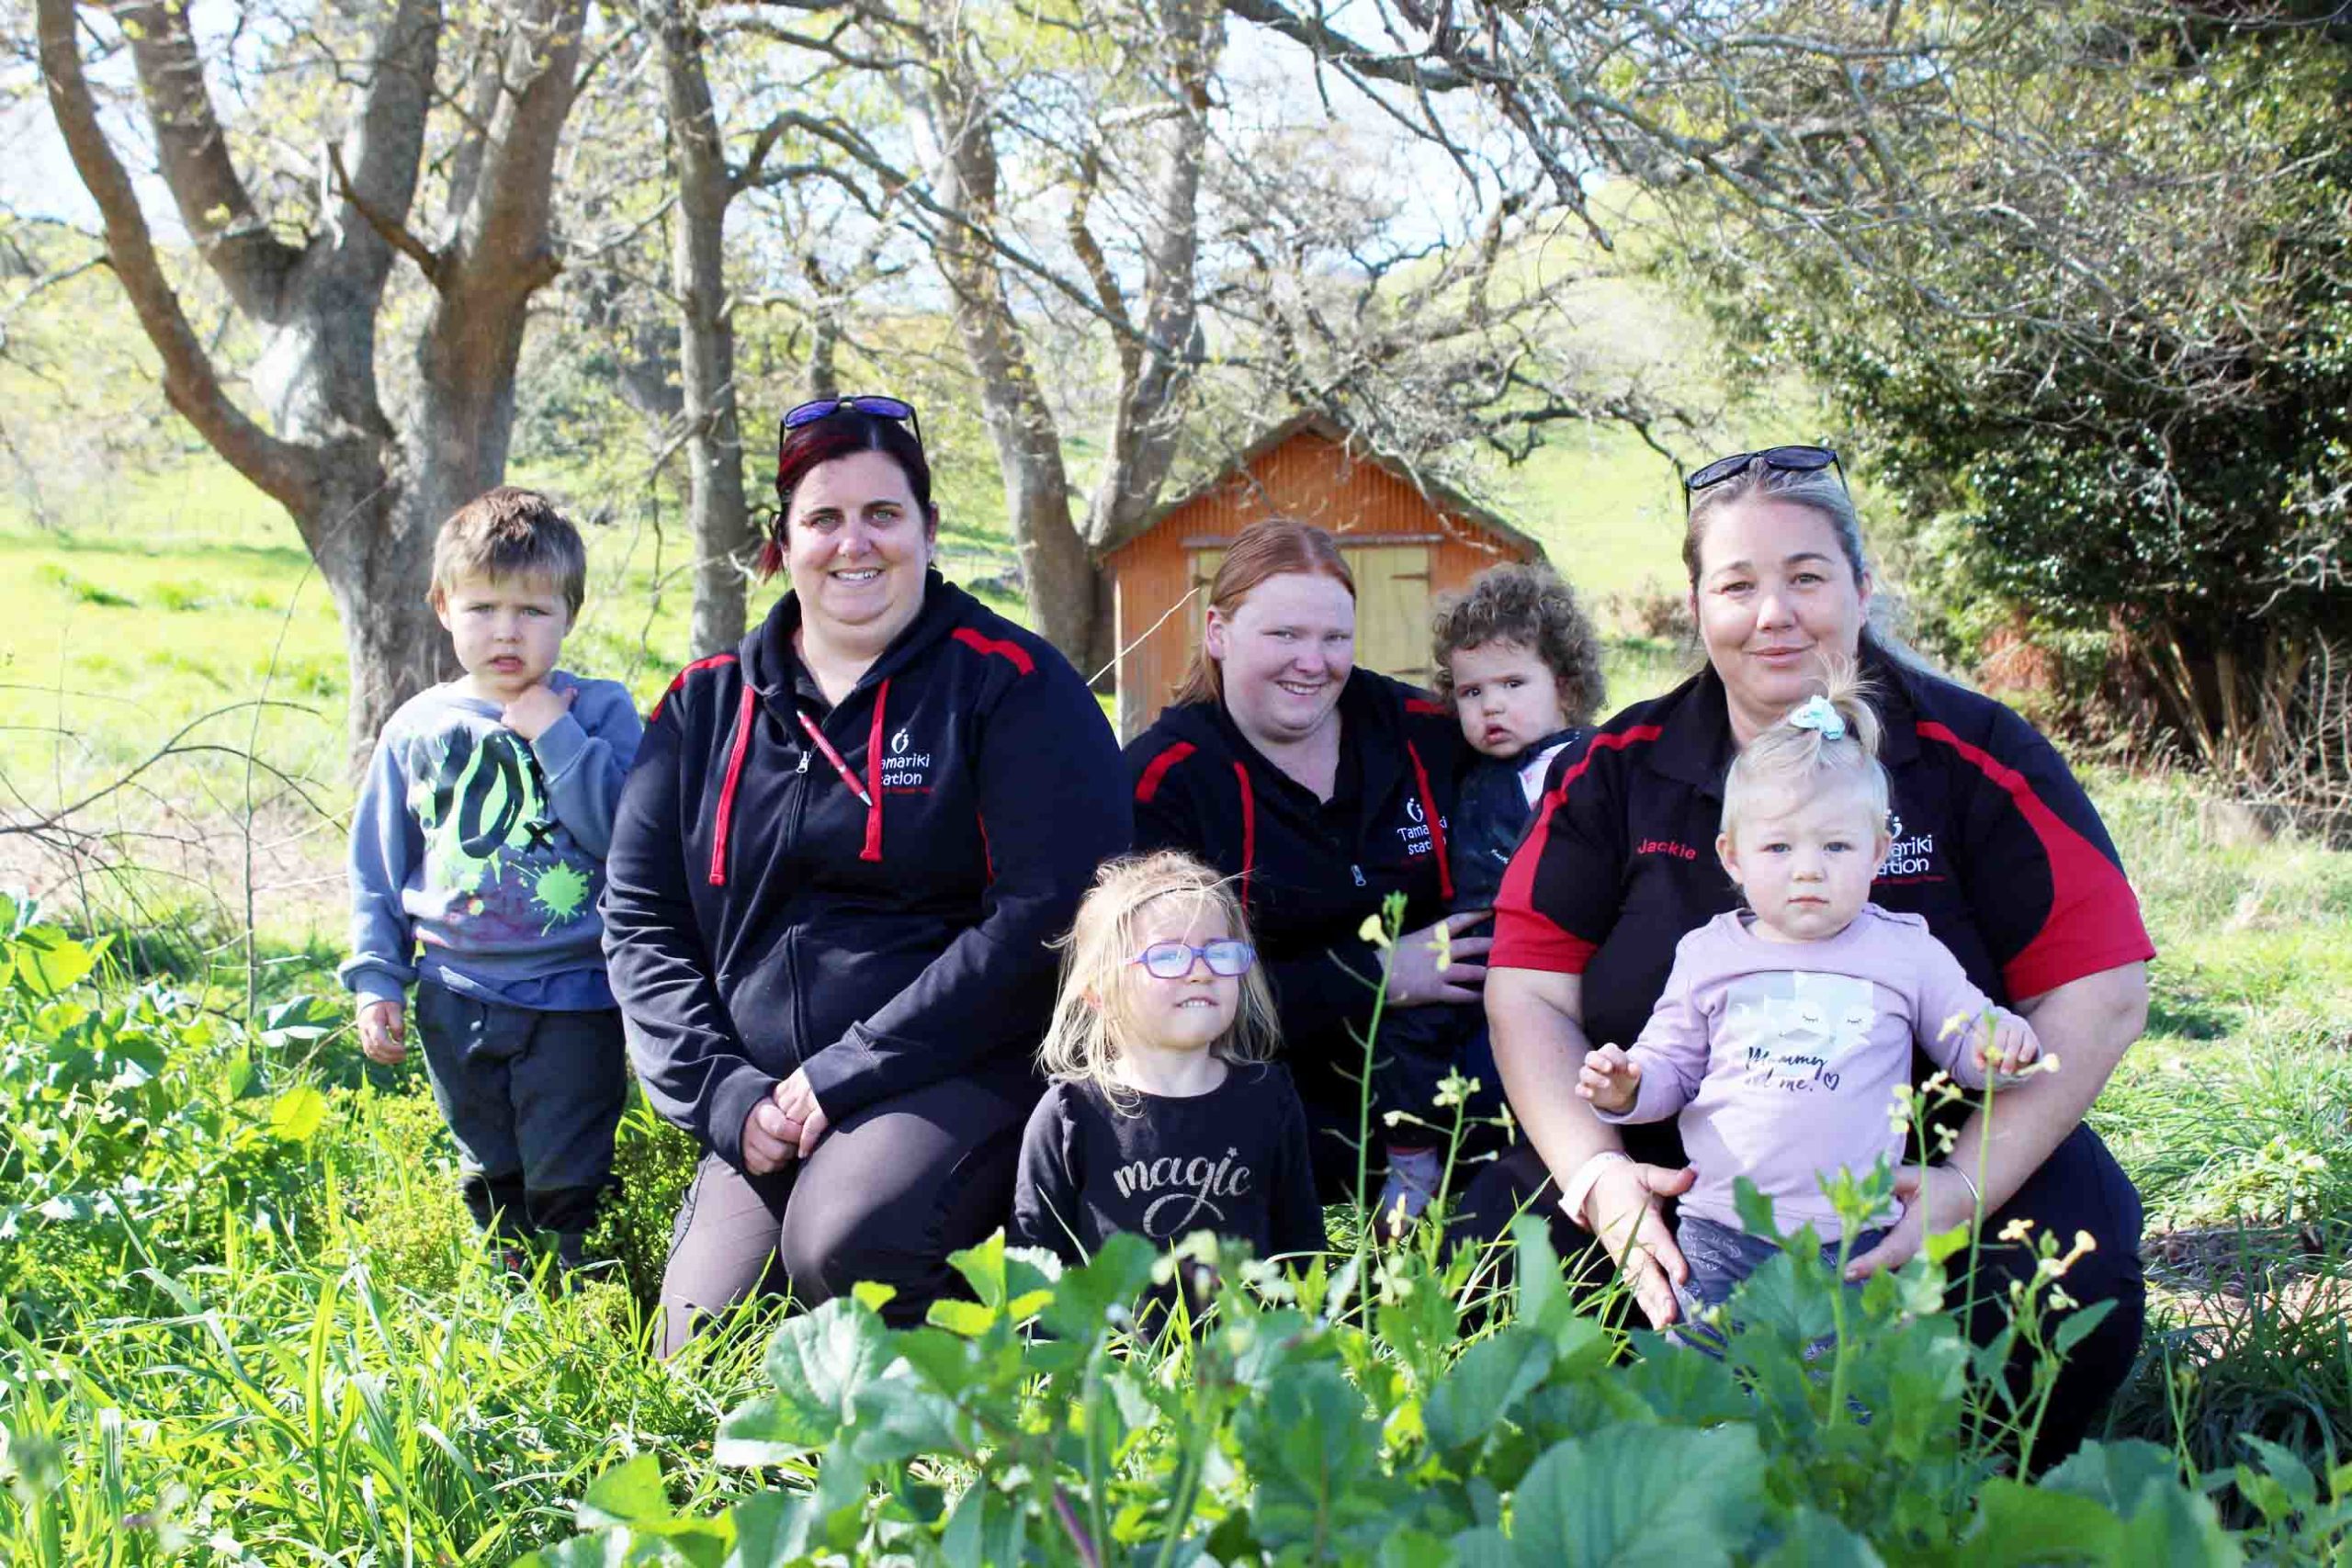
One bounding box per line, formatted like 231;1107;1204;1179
2091;776;2352;1467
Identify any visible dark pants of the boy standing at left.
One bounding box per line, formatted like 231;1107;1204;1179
416;980;628;1236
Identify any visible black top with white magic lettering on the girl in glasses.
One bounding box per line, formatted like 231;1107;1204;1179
1009;1063;1324;1262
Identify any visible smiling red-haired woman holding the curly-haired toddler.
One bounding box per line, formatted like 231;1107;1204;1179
1126;517;1487;1213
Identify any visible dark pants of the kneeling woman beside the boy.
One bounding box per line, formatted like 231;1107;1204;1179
661;1079;1037;1357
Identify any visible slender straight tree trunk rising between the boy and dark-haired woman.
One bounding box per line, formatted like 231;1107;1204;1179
654;0;752;659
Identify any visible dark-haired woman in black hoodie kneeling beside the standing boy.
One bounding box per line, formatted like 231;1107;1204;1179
605;398;1129;1354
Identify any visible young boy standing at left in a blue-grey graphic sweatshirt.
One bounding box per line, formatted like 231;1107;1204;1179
341;487;642;1265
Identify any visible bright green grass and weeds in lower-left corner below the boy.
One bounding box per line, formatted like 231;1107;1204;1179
0;940;764;1565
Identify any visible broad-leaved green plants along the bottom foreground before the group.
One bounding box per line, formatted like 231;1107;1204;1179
526;1220;2352;1568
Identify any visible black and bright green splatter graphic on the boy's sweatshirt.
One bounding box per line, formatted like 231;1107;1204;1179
409;724;595;941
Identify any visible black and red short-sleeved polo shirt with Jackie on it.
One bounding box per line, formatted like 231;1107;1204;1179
1488;647;2154;1062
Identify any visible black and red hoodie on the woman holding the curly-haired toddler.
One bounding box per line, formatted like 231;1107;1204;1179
1126;670;1463;1138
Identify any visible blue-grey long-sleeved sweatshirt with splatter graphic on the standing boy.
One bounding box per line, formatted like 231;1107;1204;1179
341;670;642;1010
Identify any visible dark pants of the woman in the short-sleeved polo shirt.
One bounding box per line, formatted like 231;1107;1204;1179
1452;1123;2147;1470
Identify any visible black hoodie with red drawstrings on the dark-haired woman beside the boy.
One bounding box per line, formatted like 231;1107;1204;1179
602;571;1131;1166
